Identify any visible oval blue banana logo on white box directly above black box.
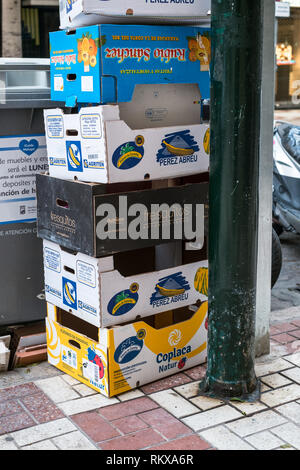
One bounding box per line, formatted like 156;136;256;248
112;135;145;170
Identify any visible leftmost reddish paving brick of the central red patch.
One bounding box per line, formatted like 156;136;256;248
72;411;121;442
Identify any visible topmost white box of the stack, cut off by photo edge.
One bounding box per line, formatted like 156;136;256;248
59;0;211;29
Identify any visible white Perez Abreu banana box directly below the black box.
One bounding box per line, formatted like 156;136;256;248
43;240;208;327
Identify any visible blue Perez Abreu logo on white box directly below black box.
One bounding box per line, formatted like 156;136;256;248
150;272;190;307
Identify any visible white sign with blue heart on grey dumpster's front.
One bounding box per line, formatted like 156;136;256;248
0;135;48;225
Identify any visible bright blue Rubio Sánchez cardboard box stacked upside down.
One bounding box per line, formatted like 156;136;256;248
50;25;211;107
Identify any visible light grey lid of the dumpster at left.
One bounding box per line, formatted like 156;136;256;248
0;58;55;108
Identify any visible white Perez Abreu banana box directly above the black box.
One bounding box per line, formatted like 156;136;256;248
44;96;209;183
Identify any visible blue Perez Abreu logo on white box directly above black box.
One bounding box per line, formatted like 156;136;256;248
157;129;199;165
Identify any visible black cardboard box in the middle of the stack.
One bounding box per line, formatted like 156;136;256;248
36;175;208;258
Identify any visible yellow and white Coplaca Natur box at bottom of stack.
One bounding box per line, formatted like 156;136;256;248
46;302;207;397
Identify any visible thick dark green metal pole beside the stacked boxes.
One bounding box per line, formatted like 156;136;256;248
200;0;262;400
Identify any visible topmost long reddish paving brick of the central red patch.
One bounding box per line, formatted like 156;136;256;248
99;397;158;421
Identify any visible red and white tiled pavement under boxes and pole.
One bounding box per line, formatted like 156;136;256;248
0;319;300;450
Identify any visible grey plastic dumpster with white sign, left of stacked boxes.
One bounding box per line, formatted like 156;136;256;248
0;59;55;326
